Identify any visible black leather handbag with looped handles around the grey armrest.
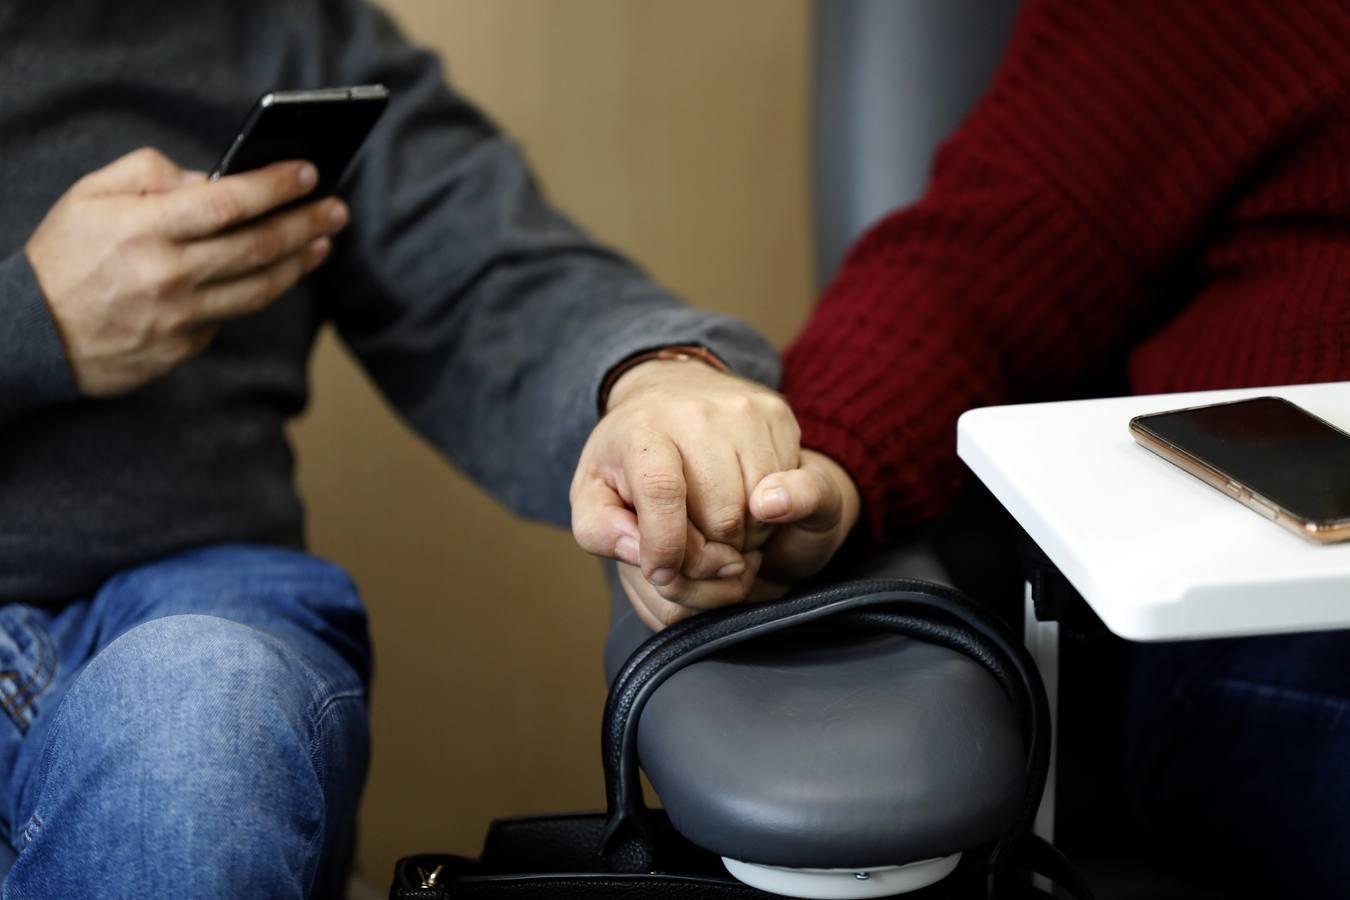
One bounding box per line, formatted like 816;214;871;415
390;579;1092;900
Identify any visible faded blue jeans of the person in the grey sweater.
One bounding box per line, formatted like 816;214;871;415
0;546;370;900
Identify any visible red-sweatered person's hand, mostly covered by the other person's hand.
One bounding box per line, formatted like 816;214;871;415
618;449;860;631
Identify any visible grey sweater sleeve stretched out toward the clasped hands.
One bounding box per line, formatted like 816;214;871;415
321;3;779;522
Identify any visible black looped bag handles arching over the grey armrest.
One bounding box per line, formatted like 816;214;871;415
601;579;1091;899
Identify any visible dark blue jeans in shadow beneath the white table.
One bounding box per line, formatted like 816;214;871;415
1130;631;1350;900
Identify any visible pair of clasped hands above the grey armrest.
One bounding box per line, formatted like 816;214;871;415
571;359;860;630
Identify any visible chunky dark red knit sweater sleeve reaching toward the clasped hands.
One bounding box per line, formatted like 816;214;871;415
784;0;1350;550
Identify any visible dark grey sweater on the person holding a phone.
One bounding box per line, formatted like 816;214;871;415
0;0;778;602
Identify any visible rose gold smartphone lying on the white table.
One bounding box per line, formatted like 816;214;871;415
1130;397;1350;544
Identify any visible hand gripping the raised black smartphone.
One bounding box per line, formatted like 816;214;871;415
26;150;347;397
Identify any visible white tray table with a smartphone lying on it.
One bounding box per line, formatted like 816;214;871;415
957;382;1350;837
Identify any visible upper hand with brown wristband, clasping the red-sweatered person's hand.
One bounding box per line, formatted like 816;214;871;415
571;360;801;609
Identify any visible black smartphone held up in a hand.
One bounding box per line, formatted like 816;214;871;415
211;85;389;197
